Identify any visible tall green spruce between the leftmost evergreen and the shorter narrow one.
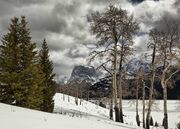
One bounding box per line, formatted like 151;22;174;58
16;17;43;110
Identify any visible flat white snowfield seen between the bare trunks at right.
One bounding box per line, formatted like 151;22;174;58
123;100;180;129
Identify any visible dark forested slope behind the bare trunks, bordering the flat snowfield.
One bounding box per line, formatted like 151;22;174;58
89;78;180;100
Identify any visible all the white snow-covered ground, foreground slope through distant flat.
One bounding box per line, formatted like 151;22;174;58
0;94;180;129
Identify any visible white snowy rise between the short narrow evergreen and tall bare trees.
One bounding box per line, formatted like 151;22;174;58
54;93;109;119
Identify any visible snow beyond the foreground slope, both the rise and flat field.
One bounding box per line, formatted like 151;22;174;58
54;94;180;129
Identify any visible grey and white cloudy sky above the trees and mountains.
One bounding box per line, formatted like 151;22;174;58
0;0;180;80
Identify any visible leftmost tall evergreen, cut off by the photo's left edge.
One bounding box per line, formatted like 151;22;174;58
0;17;20;104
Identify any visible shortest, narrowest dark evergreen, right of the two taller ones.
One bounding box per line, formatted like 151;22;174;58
39;39;56;112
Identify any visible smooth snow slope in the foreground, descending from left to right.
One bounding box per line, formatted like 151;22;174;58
0;103;142;129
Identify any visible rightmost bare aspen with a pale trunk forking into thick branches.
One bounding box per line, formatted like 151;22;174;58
158;20;180;129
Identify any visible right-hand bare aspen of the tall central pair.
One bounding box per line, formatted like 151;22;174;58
118;12;139;123
